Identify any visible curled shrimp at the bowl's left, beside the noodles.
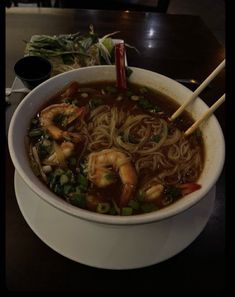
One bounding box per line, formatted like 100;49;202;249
40;103;85;142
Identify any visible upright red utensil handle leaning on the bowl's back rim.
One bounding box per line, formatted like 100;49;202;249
115;42;127;90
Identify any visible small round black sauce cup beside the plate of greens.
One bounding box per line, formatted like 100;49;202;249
14;56;52;90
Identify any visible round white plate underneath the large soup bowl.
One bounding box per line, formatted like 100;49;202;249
15;171;215;269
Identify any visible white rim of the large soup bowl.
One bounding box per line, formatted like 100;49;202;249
8;65;225;225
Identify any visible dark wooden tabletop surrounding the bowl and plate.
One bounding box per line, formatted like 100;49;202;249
5;8;225;296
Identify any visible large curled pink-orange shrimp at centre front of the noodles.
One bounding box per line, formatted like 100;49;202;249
87;149;137;207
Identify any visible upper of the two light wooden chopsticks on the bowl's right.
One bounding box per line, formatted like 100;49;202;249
170;59;225;121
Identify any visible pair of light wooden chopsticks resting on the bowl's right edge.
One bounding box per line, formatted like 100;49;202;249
170;59;225;136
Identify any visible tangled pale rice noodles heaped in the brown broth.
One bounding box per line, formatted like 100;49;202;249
79;105;202;184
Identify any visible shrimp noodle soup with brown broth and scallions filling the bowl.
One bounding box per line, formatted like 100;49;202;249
28;82;204;215
